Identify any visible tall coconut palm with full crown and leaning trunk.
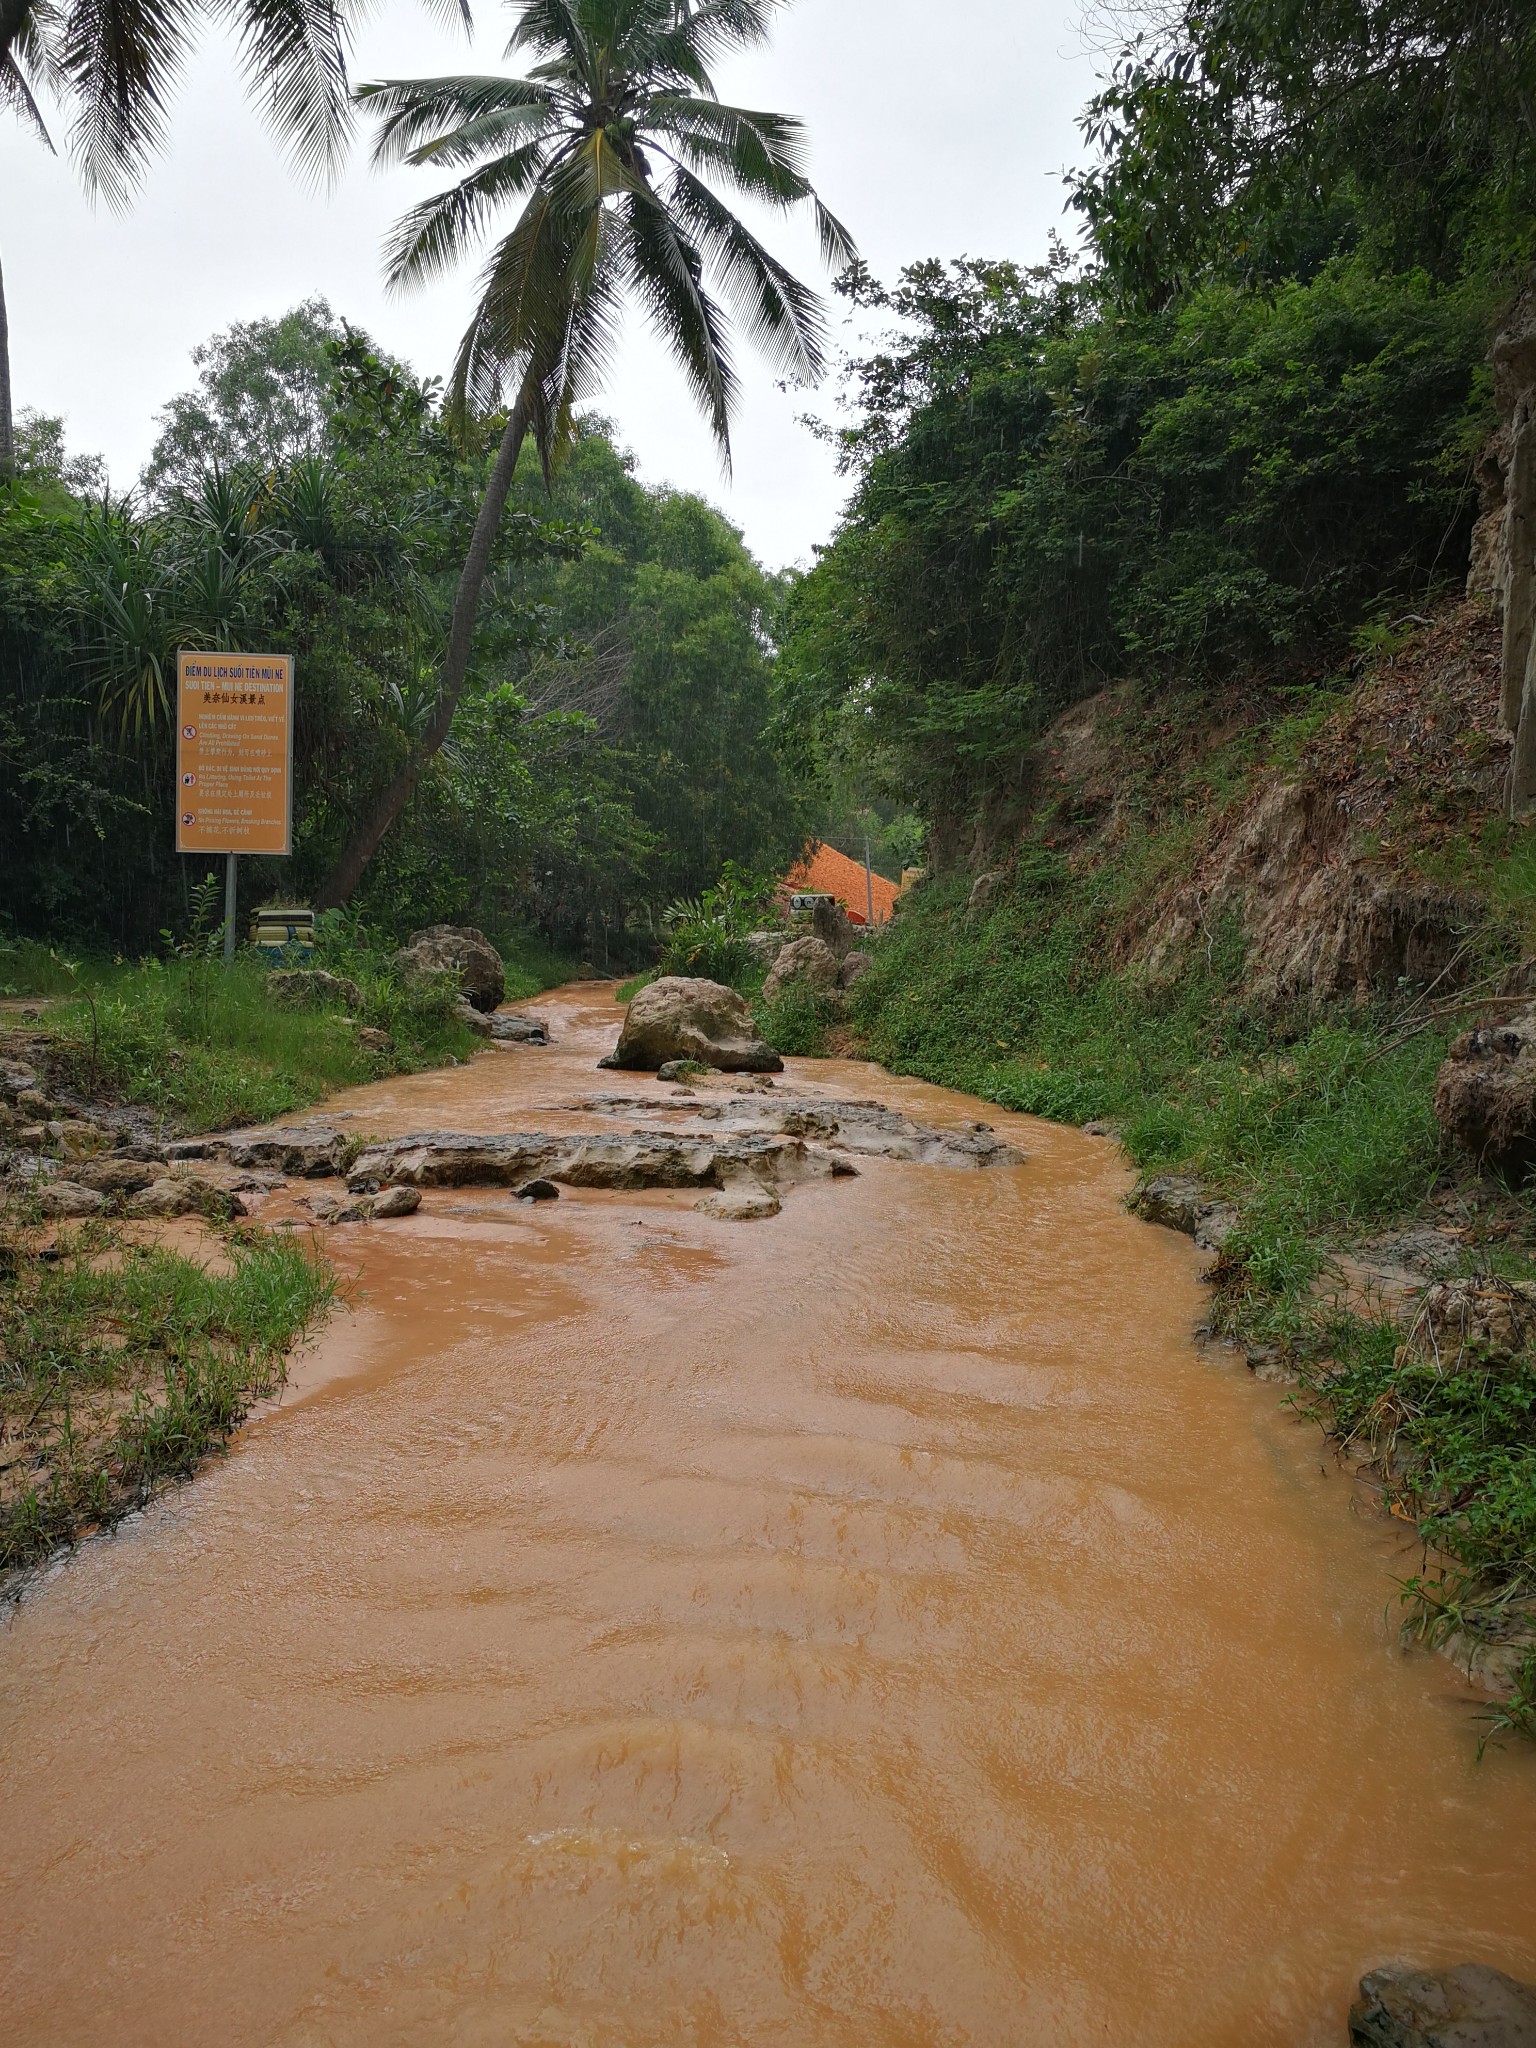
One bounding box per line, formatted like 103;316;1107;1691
317;0;856;905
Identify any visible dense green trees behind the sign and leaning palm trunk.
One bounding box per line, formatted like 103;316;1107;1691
0;305;803;961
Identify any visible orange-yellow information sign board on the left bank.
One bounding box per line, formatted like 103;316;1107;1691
176;653;293;854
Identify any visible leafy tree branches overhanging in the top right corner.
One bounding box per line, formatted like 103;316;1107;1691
1071;0;1536;305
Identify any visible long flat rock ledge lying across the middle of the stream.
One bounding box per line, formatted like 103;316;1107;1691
348;1130;854;1192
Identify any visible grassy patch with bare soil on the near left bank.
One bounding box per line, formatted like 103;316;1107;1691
0;1202;334;1569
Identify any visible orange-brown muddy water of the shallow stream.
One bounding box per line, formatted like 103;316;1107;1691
0;987;1536;2048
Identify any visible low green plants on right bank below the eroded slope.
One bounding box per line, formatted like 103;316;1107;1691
856;844;1444;1236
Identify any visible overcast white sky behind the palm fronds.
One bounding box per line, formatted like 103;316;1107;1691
0;0;1096;567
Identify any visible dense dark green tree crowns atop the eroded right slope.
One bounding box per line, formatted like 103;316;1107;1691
782;262;1489;831
